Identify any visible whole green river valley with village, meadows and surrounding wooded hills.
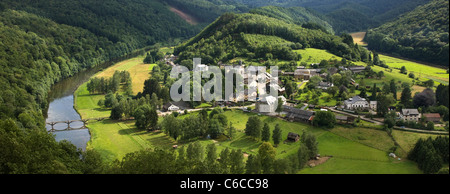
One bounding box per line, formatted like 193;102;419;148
0;0;449;174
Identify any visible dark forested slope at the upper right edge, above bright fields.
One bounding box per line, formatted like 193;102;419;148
366;0;449;66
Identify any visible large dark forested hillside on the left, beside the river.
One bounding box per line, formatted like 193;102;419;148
0;0;202;174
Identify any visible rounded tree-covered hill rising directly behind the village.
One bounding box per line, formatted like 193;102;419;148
175;14;368;66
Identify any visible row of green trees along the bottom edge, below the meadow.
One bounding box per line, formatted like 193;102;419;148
107;132;318;174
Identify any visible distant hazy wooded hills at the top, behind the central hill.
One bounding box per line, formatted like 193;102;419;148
167;0;430;34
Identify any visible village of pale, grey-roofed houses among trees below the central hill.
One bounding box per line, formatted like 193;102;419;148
164;55;444;136
